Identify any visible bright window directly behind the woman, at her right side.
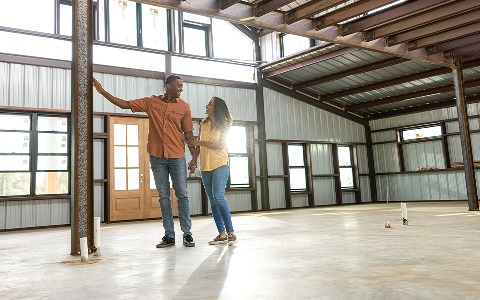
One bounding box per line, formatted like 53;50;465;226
228;125;250;187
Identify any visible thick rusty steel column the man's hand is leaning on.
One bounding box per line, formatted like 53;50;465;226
70;0;93;255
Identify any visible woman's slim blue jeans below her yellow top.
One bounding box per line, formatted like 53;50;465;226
201;165;233;233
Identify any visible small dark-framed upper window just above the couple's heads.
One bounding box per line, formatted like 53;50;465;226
182;13;212;56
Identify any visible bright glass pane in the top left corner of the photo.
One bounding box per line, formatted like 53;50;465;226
0;0;55;33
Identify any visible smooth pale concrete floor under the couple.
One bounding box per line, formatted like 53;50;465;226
0;201;480;299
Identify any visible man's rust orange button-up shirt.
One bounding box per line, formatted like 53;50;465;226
129;95;193;158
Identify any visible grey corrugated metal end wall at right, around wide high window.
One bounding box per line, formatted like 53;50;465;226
370;103;480;201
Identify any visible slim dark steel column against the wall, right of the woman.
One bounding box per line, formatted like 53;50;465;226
254;36;270;210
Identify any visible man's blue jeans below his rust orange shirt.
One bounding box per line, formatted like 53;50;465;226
150;155;192;238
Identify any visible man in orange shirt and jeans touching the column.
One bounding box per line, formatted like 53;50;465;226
93;75;197;248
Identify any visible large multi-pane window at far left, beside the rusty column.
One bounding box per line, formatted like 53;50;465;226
0;114;70;196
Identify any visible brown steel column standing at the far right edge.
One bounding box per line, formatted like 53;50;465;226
452;60;478;210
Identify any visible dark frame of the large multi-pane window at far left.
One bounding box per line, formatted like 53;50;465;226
0;111;71;200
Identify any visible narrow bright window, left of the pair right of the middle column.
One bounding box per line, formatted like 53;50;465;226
288;144;307;191
